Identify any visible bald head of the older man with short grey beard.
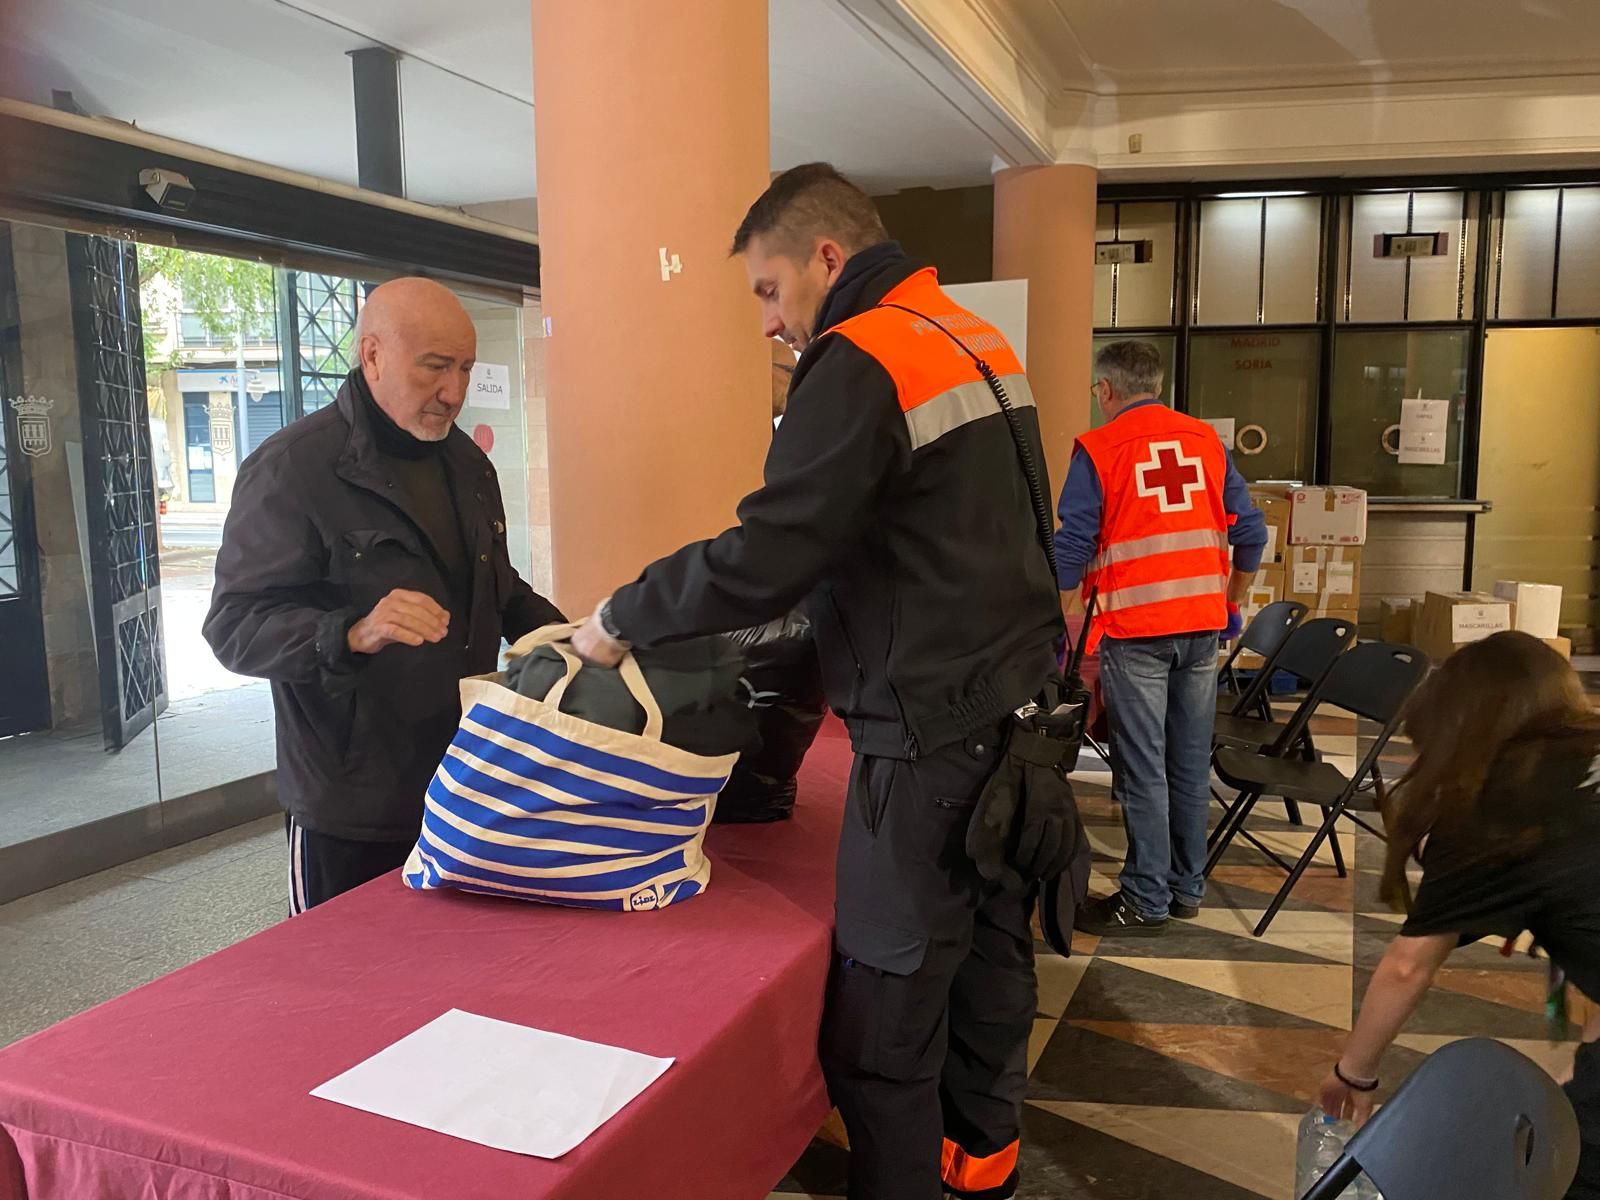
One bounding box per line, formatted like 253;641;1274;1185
355;278;478;442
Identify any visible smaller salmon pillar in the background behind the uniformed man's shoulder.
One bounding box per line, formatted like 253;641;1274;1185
995;165;1098;492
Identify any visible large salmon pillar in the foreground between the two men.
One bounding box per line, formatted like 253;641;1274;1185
533;0;771;619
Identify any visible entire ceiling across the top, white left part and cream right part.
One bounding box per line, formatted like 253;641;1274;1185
0;0;1600;211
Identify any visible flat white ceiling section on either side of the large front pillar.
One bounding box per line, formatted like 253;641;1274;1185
0;0;994;205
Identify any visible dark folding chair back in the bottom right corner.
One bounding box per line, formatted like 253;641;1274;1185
1301;1037;1581;1200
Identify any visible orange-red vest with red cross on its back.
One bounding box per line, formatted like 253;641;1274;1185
1077;405;1232;645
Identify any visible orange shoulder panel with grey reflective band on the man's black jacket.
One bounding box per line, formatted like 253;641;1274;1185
829;267;1034;453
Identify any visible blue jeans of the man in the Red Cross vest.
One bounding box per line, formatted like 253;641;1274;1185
1101;634;1216;917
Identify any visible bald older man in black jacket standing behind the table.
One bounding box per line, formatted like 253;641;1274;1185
205;278;562;912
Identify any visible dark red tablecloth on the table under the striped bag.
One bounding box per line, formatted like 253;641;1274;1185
0;736;850;1200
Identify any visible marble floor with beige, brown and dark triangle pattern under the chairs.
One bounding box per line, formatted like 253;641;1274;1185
773;700;1594;1200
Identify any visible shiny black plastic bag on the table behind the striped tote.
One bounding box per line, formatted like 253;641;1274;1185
715;613;826;824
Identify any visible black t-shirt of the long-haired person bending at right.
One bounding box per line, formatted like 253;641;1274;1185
1400;739;1600;997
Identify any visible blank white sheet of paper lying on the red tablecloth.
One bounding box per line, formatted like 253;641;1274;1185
310;1008;674;1158
